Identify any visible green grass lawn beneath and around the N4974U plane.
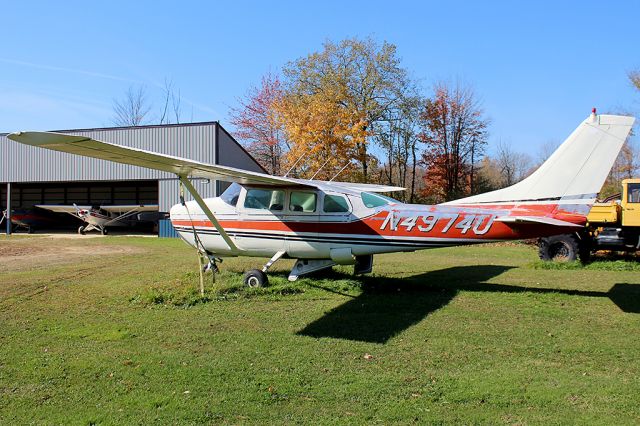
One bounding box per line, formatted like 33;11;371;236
0;237;640;424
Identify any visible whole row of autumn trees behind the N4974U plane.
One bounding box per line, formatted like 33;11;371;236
230;38;544;203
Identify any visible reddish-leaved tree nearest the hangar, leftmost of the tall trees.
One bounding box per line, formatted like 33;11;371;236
231;74;289;175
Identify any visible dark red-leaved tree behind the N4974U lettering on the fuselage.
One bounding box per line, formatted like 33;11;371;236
420;82;489;202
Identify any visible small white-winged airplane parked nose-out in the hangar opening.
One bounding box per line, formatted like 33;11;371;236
36;204;158;235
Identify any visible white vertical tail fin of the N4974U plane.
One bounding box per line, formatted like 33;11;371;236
446;110;635;205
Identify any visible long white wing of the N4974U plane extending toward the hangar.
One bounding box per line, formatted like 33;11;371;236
7;132;314;187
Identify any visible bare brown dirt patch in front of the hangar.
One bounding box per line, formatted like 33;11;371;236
0;237;144;272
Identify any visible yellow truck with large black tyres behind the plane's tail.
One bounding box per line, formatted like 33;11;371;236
538;179;640;262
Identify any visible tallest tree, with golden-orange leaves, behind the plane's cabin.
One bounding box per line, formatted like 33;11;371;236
280;38;407;182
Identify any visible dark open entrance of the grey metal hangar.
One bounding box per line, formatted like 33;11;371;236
0;180;158;232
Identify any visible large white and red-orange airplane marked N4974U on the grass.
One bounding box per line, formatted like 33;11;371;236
8;110;634;286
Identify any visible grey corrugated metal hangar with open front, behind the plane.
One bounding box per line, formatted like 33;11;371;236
0;121;265;237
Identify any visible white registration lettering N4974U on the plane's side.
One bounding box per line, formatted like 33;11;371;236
380;211;497;235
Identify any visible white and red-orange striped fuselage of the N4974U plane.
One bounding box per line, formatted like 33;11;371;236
170;187;585;260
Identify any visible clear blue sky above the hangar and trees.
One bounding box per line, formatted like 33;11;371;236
0;0;640;156
